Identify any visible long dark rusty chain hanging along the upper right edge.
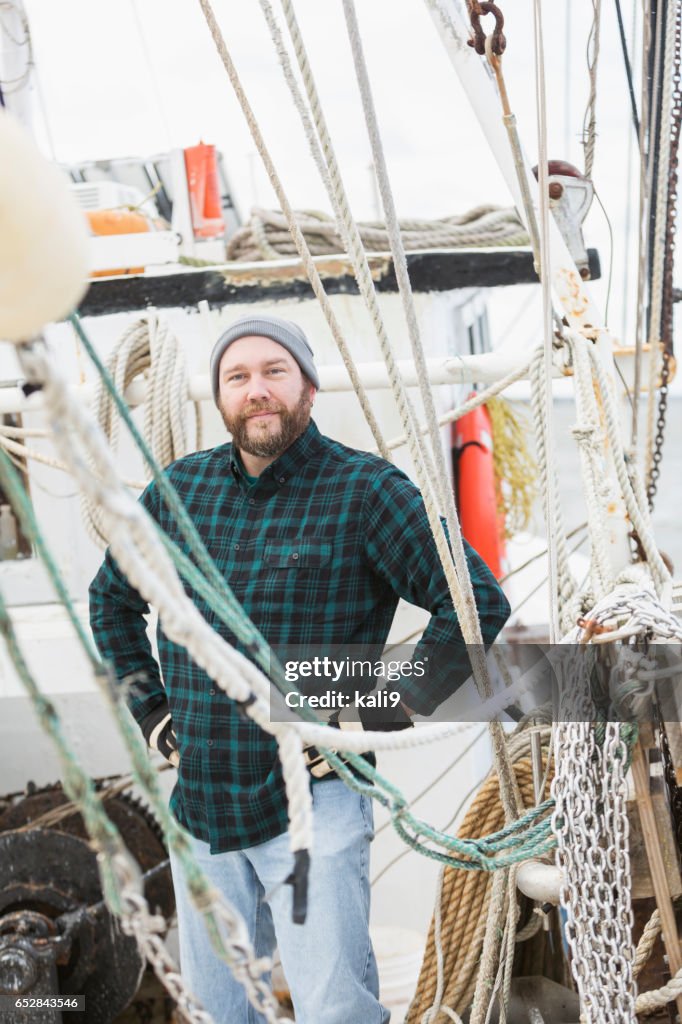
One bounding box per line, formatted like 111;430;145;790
646;3;682;511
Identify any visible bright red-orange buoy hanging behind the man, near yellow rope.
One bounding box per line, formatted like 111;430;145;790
453;397;506;580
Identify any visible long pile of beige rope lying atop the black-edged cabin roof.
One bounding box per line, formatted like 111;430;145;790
227;205;528;263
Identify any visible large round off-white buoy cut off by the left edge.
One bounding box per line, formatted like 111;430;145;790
0;108;89;341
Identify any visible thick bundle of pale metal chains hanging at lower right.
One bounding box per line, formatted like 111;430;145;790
552;658;636;1024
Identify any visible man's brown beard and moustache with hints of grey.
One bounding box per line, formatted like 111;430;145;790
218;381;311;459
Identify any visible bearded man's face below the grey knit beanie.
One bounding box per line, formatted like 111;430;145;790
218;335;315;459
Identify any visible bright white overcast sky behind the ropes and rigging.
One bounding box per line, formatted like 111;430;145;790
2;0;667;360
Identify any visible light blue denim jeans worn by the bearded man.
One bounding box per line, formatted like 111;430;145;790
171;779;390;1024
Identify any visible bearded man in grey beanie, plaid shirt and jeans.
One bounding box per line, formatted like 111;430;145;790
90;316;509;1024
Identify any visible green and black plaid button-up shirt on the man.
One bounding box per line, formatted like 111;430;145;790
90;423;509;852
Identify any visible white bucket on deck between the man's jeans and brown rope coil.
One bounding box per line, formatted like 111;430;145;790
371;926;426;1024
